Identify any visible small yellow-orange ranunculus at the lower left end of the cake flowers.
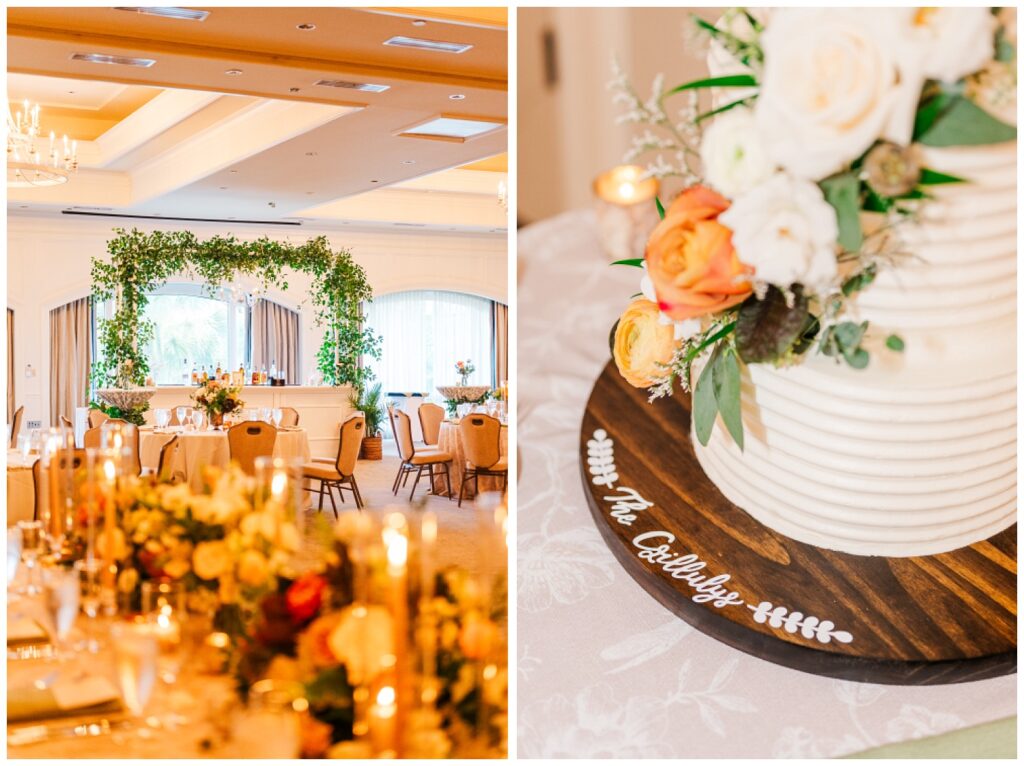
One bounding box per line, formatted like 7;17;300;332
612;298;676;388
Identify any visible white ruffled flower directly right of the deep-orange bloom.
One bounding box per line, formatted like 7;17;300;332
718;173;839;291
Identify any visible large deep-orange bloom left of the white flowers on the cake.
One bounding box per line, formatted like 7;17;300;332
645;186;754;322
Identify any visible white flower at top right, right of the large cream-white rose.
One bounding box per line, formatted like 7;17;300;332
874;7;997;145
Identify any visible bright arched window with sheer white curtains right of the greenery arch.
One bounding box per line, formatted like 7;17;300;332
367;290;494;398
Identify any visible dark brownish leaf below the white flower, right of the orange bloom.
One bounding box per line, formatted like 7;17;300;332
736;285;807;365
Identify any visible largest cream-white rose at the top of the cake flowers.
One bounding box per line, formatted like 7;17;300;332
755;8;896;180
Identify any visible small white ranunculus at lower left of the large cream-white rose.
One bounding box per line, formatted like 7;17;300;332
700;107;775;199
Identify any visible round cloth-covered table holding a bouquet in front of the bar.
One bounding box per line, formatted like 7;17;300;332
139;428;310;492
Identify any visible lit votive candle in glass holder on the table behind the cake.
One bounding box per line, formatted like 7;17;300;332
594;165;658;260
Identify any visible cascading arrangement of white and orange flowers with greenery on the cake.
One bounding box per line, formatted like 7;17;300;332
610;7;1017;449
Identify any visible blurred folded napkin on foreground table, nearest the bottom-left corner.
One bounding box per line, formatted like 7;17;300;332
7;675;121;721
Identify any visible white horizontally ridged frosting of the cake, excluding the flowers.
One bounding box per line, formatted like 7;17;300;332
694;142;1017;556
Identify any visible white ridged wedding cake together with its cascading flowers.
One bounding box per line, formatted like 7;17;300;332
613;8;1017;556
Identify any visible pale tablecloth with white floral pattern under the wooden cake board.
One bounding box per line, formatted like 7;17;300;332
518;212;1017;758
